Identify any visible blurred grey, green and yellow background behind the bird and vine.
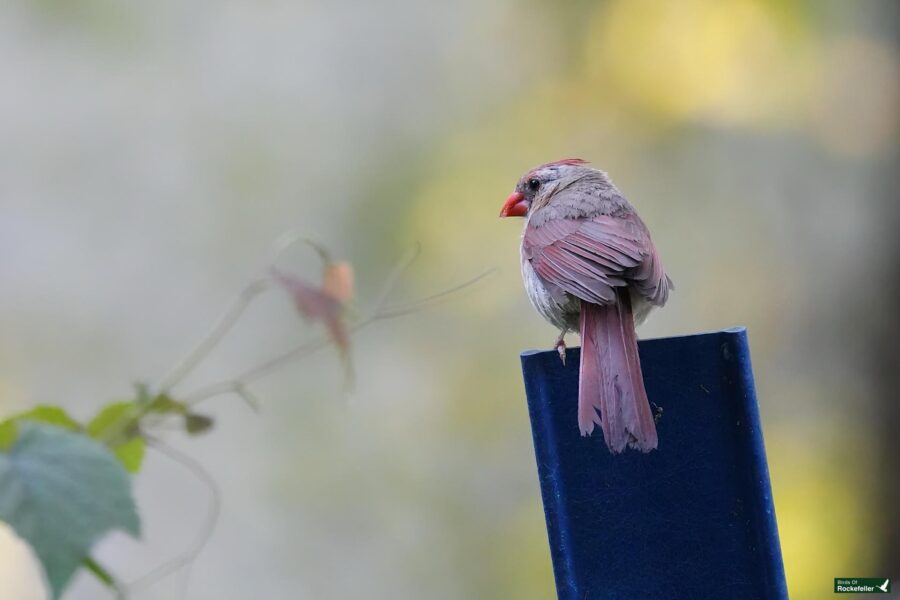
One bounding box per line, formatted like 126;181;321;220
0;0;900;600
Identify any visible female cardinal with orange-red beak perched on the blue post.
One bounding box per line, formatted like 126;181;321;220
500;158;674;454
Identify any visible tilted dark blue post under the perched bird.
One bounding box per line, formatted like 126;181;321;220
522;328;788;600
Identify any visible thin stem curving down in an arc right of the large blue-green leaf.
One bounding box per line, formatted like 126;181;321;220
127;438;222;592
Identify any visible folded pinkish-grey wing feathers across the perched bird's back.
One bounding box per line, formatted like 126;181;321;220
522;213;672;306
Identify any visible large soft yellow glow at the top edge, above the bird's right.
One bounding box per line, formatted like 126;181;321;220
585;0;815;125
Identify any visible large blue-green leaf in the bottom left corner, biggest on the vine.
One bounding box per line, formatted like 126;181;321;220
0;422;140;598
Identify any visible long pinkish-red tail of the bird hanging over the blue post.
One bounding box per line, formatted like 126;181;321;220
578;288;657;454
